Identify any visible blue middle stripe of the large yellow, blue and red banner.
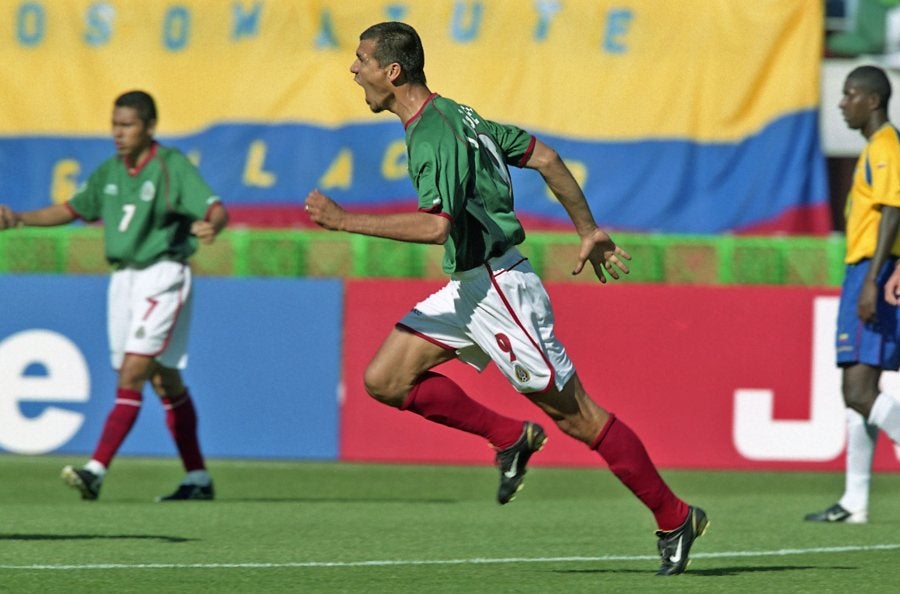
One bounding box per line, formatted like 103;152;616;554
0;110;828;233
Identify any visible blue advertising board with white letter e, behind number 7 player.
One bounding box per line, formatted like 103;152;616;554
0;274;345;460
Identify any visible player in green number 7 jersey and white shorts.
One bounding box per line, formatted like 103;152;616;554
0;91;228;501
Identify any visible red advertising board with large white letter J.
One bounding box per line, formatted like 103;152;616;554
340;280;900;470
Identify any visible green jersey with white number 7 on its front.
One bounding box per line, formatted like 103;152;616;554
68;144;219;267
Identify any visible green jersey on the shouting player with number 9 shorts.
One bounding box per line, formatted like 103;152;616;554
406;94;534;273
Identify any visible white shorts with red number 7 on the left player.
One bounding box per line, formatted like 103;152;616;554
107;261;193;369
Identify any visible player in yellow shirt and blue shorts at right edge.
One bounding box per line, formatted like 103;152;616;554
805;66;900;524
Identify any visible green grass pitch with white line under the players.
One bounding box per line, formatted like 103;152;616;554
0;455;900;593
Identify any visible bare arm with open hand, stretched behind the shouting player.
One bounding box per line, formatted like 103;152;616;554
526;140;631;283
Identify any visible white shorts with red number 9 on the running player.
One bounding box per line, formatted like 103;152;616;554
398;248;575;393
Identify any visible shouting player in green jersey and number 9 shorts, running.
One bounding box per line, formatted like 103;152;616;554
306;22;707;575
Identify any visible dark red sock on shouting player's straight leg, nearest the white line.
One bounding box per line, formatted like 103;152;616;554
591;414;688;531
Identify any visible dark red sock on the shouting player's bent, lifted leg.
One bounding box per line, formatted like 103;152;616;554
400;371;523;450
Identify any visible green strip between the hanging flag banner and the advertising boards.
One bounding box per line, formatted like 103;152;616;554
0;226;844;286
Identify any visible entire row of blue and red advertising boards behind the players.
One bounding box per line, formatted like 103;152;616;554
0;266;900;471
